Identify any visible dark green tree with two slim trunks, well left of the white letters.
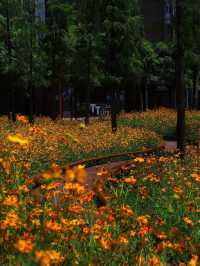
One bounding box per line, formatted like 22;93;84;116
46;0;74;118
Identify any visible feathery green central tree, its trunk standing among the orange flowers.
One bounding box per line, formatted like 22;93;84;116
102;0;141;132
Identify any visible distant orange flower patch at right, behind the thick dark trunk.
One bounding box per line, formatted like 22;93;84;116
119;108;200;144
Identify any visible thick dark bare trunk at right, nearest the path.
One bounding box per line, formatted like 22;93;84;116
176;0;185;156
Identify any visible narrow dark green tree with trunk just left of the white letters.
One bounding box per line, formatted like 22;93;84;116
74;0;100;124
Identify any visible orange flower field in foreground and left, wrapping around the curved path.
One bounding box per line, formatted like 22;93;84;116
0;112;200;266
